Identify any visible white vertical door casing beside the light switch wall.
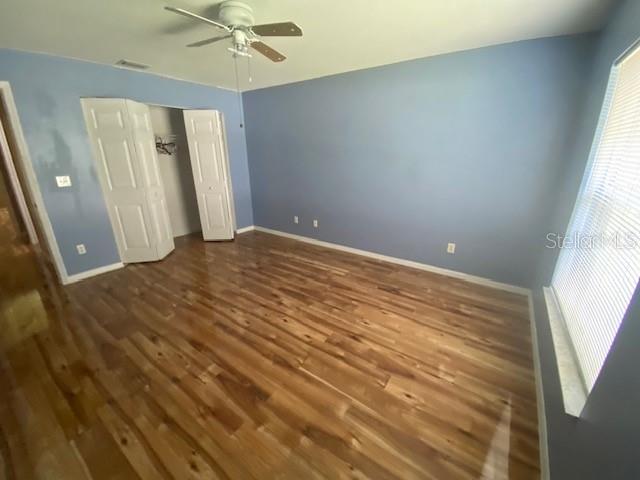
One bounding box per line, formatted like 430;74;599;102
0;81;68;283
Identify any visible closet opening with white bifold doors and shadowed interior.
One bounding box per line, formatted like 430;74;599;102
82;98;236;263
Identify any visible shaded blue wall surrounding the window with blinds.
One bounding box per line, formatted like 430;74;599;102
534;0;640;480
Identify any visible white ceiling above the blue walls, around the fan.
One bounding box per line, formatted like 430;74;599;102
0;0;615;90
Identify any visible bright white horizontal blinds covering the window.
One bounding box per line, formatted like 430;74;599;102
551;42;640;392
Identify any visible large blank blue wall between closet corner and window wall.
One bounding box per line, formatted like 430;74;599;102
243;36;594;286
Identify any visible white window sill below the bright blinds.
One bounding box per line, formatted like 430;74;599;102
544;287;587;417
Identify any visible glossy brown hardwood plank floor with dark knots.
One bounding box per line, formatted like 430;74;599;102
0;232;539;480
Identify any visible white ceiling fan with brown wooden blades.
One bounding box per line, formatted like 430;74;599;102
164;0;302;62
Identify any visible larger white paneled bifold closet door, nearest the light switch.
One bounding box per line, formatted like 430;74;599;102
82;98;174;263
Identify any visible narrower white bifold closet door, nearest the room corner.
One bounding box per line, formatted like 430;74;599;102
184;110;235;240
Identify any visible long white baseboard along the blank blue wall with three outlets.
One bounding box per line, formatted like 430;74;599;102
254;225;531;295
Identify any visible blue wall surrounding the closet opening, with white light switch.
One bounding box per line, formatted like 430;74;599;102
0;49;253;274
